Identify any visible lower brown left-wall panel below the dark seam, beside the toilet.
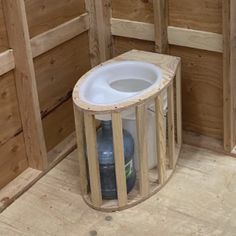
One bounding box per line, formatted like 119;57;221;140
43;99;75;151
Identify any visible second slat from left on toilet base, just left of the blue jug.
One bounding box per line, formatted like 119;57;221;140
84;113;102;207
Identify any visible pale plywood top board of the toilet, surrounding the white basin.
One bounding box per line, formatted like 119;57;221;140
73;50;180;113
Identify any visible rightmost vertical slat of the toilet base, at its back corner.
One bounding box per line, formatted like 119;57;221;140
175;63;182;146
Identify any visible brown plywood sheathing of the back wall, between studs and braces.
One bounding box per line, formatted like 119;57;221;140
112;0;223;140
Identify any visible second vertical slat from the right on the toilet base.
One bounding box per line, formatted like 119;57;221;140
167;83;175;169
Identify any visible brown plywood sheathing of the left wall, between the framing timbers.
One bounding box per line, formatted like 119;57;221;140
0;0;91;192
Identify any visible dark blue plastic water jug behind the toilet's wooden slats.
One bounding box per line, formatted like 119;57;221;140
97;121;136;199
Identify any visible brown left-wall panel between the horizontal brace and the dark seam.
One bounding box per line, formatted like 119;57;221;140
34;32;90;114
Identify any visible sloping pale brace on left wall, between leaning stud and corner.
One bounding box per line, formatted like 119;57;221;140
30;13;89;57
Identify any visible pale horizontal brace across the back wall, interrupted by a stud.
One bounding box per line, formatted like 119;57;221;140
111;18;223;52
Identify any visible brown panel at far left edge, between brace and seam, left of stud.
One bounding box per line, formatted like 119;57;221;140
0;72;22;145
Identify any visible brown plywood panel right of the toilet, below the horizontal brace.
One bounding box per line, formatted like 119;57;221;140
170;46;223;139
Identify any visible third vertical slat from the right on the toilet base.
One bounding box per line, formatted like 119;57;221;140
155;94;167;184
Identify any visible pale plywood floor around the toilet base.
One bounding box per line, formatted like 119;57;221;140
0;146;236;236
